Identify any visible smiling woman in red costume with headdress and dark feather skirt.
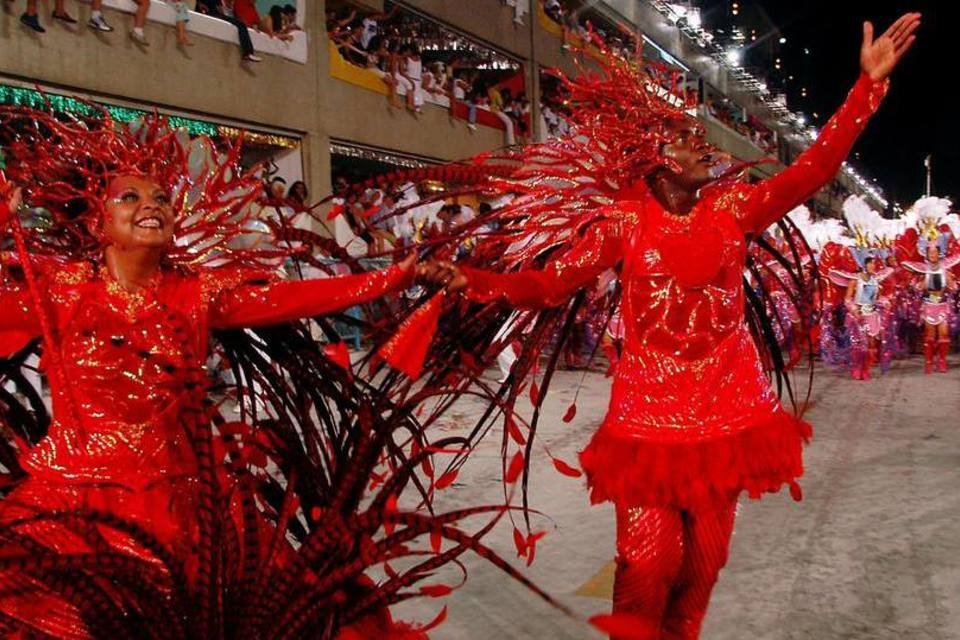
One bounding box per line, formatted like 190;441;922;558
0;108;564;640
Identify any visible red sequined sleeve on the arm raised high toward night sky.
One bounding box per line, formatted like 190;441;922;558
737;74;890;233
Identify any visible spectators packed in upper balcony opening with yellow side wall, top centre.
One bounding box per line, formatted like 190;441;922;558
327;0;531;145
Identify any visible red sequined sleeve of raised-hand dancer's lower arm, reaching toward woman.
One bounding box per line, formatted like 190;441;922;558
463;219;624;309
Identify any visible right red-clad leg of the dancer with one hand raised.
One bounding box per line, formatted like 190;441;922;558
662;499;737;640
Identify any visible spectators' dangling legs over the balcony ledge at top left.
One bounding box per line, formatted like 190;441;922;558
4;0;299;62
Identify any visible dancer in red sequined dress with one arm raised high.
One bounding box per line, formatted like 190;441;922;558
414;13;920;639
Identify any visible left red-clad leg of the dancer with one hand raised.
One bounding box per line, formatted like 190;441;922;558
613;505;684;640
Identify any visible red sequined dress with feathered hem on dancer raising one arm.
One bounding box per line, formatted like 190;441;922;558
464;76;887;508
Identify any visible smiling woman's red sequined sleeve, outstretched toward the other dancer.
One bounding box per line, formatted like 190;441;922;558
210;266;414;329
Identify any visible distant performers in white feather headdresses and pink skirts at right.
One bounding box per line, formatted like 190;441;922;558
790;196;960;380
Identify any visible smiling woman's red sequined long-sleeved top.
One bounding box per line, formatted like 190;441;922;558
0;263;412;486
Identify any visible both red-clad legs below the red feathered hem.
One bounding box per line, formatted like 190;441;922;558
613;499;737;640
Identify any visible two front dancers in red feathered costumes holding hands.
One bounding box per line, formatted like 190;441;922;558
0;8;928;639
